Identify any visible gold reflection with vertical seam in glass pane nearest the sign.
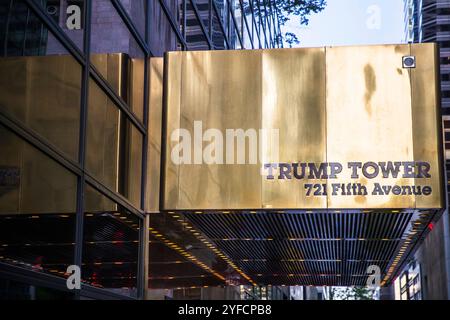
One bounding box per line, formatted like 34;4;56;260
86;80;143;208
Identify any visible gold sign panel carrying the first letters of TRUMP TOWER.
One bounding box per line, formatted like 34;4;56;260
258;48;327;209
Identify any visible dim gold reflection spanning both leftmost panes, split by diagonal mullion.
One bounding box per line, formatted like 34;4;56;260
0;56;81;214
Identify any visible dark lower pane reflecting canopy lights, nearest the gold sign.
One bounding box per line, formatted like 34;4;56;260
82;185;140;297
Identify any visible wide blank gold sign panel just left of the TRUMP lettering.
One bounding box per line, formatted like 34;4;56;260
177;51;262;209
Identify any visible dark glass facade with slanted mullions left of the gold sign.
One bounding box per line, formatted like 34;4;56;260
0;0;282;299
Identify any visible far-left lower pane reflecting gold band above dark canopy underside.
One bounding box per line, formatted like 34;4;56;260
0;126;76;277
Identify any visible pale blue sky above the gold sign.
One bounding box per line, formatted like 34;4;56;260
283;0;405;47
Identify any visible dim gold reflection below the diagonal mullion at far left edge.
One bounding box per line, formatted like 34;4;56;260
0;125;77;214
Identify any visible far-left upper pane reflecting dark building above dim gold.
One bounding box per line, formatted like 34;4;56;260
0;1;81;161
